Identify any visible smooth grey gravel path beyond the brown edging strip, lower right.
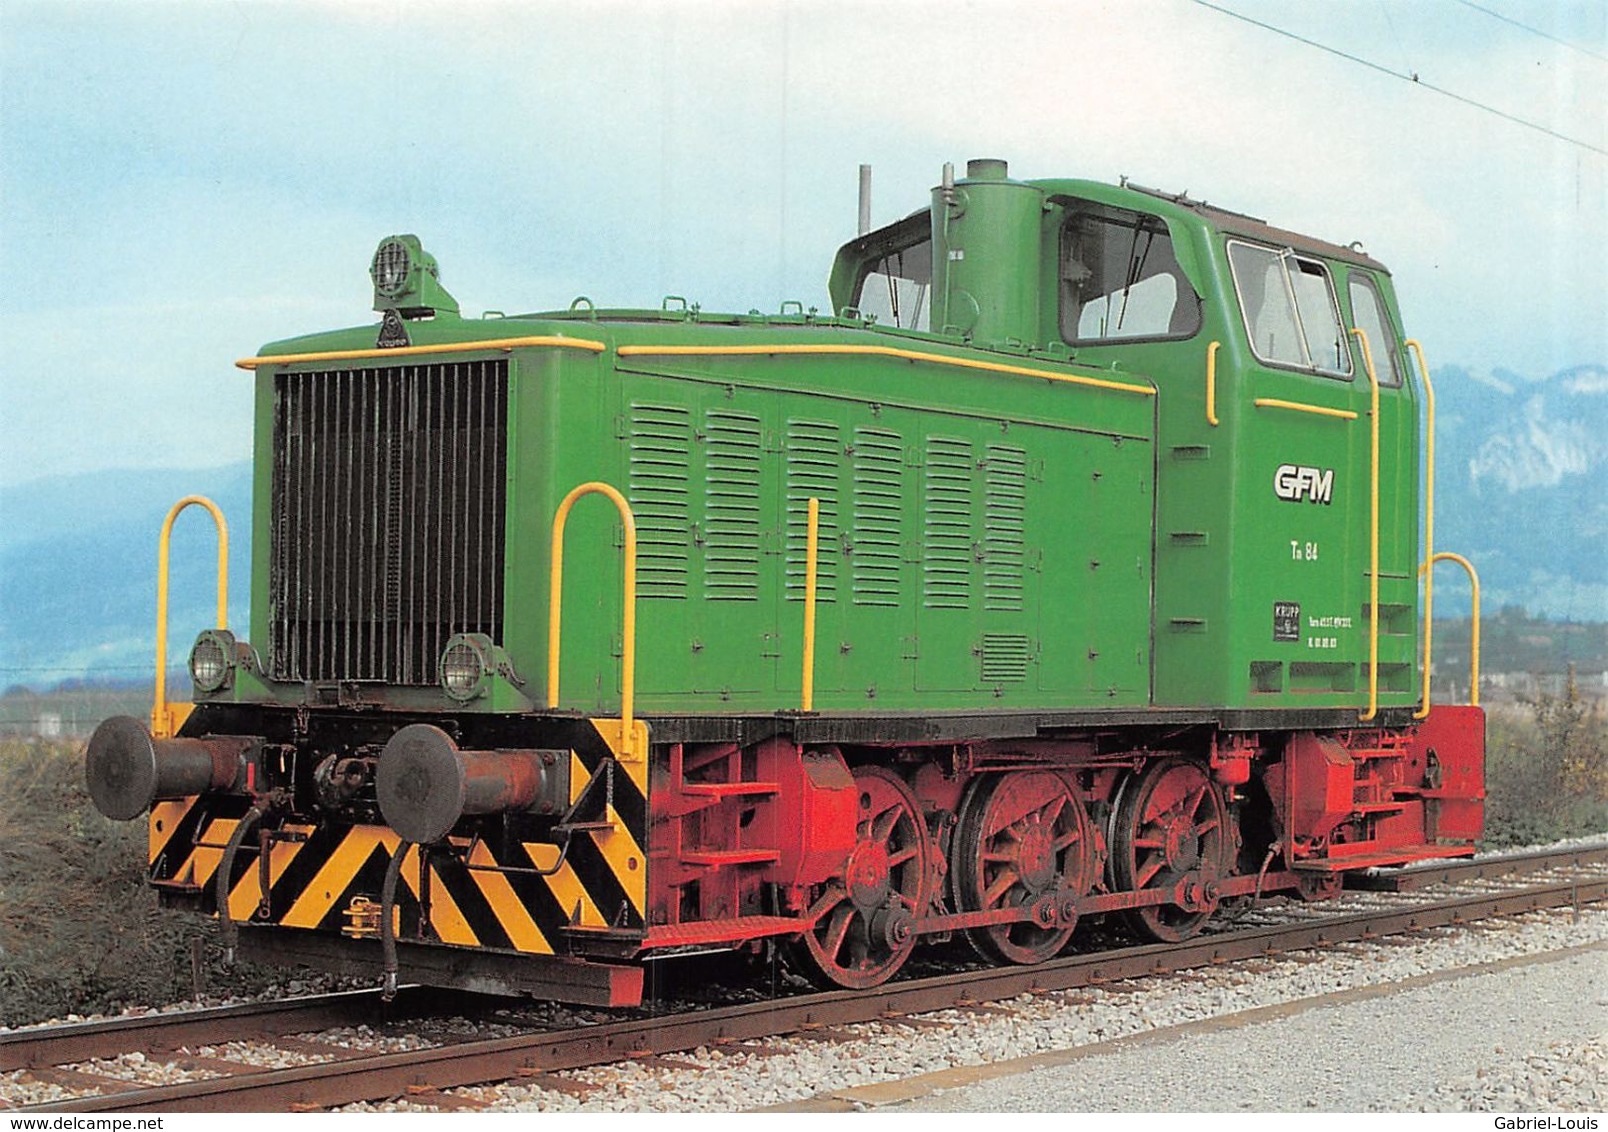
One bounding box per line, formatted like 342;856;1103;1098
868;949;1608;1113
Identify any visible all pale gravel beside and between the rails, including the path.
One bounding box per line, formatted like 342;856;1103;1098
0;849;1608;1113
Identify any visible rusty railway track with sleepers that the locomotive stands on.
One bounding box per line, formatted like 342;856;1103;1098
0;847;1608;1111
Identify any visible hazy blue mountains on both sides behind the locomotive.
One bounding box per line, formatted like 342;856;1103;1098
0;365;1608;688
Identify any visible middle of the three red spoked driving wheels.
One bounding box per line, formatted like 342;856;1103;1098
950;770;1098;963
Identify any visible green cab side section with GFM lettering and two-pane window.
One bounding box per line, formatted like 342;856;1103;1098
1227;238;1372;708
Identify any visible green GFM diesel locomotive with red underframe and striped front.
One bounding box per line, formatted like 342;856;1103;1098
87;161;1484;1003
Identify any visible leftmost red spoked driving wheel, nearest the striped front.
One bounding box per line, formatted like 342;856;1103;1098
798;767;931;991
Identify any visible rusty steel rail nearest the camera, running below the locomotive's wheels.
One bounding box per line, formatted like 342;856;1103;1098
19;878;1608;1113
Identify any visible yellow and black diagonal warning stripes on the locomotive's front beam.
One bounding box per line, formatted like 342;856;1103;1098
150;719;648;955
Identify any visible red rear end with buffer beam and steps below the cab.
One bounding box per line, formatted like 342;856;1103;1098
1267;708;1486;873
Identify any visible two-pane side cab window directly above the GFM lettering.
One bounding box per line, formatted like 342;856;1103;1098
1229;241;1351;378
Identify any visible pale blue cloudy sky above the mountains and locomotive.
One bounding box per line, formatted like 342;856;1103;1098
0;0;1608;486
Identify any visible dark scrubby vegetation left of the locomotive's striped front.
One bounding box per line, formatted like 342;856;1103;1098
0;740;265;1026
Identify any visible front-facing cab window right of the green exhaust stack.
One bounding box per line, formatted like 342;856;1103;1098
1060;204;1201;342
